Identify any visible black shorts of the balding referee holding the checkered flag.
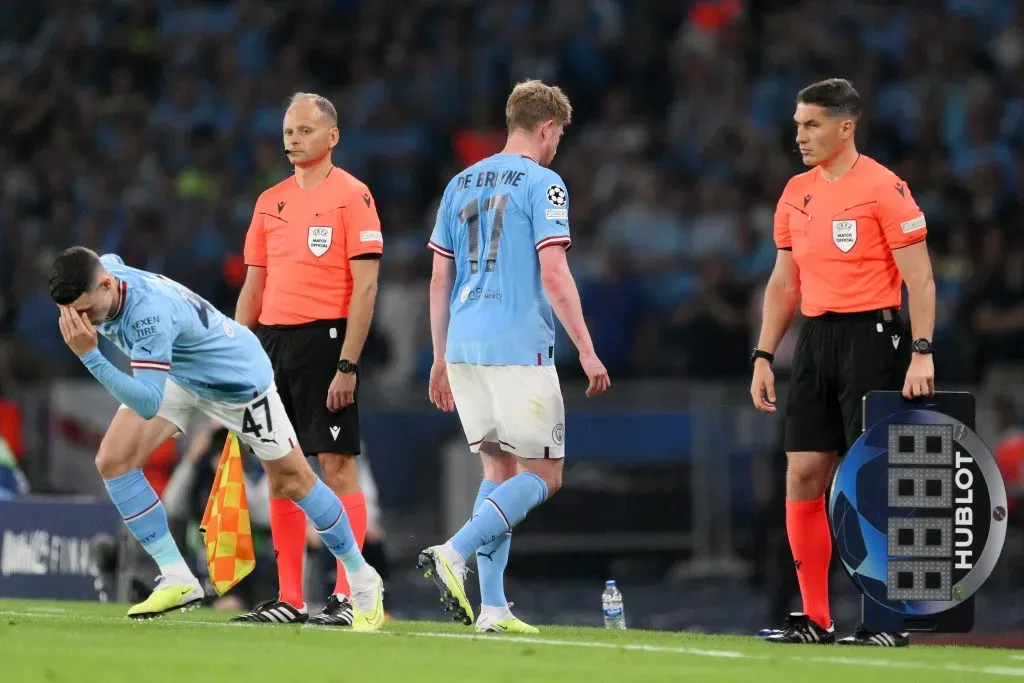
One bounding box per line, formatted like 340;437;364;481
256;318;359;456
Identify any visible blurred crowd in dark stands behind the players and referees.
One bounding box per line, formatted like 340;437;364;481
0;0;1024;634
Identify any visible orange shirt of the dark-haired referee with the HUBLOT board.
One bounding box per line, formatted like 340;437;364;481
774;155;928;316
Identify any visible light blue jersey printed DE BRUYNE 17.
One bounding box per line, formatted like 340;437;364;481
429;154;570;366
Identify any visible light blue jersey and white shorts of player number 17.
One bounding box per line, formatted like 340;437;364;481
429;154;570;459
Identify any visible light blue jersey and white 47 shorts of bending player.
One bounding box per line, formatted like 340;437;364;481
82;254;297;460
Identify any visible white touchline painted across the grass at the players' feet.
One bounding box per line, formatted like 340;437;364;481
0;610;1024;678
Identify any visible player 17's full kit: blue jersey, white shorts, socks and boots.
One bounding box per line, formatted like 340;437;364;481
418;154;570;634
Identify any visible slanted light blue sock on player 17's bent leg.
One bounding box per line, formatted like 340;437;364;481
452;472;548;557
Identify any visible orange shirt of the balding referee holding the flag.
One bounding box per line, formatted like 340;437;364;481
245;168;384;325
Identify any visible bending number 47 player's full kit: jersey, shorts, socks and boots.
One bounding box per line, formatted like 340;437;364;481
72;254;384;631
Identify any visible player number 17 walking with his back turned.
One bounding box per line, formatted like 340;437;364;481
419;81;610;633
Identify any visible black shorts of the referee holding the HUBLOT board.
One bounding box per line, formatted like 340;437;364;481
784;308;912;455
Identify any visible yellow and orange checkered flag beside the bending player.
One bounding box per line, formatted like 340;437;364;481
199;432;256;595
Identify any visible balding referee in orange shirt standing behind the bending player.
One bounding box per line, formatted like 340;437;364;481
233;92;384;626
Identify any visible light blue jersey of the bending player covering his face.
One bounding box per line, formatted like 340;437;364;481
95;254;273;403
